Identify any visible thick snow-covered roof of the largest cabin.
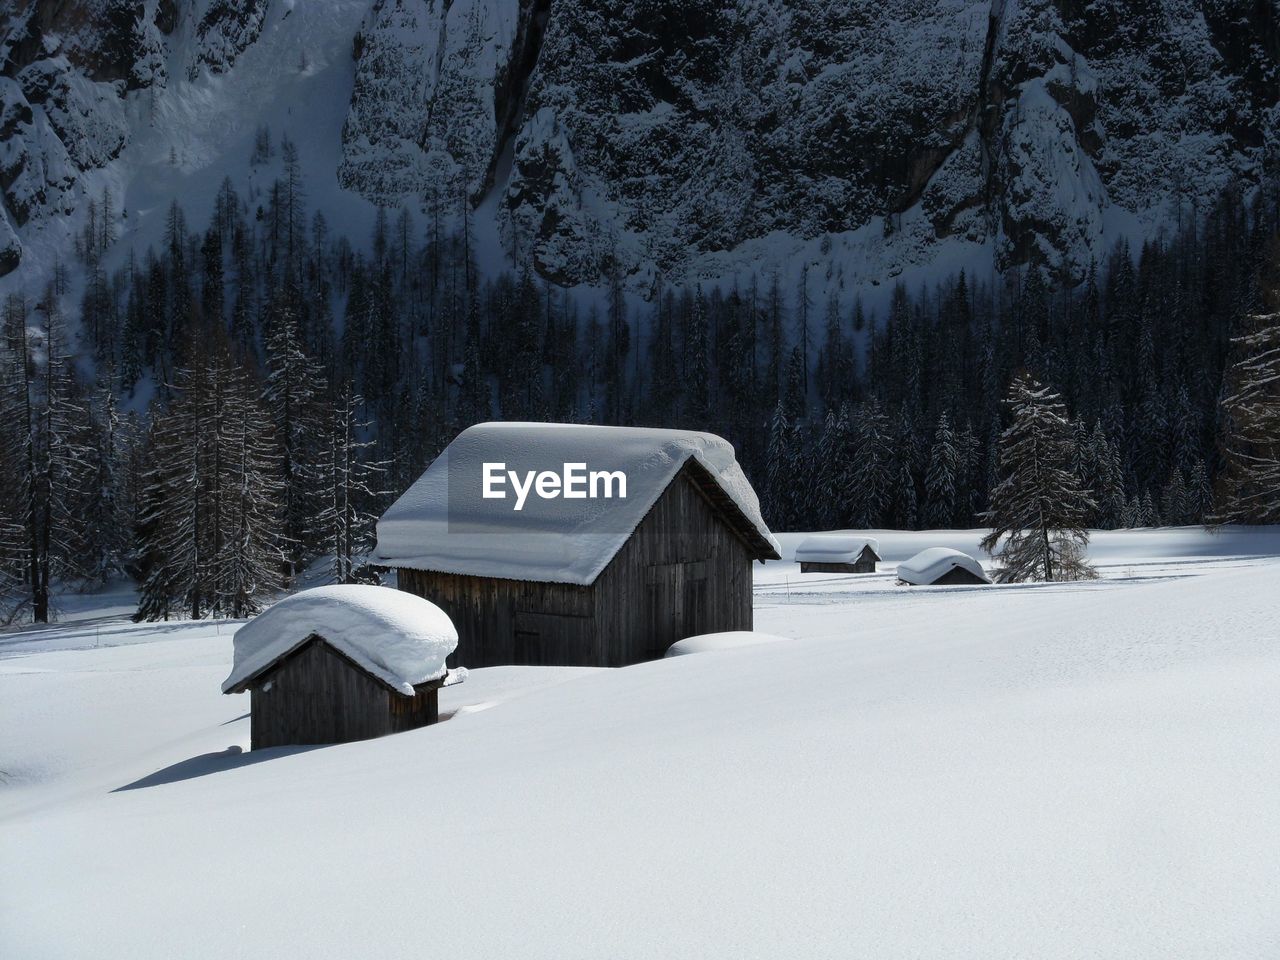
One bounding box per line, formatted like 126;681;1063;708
371;422;780;585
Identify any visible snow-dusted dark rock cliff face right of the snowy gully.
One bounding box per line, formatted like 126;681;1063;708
344;0;1280;282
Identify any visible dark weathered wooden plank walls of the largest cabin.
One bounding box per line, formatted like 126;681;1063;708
398;467;753;667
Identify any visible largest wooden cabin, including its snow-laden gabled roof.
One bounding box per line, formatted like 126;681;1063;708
372;422;780;667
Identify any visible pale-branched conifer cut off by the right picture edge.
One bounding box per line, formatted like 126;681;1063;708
1217;314;1280;524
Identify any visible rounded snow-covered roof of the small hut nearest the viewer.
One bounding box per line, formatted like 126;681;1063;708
223;584;458;695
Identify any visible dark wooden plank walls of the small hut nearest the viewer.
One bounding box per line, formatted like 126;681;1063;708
250;637;439;750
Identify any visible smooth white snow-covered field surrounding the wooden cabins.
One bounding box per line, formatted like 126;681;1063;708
0;530;1280;960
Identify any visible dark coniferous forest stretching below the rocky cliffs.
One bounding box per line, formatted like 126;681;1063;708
0;131;1280;621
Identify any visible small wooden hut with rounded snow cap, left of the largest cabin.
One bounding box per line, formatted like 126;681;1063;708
223;585;458;750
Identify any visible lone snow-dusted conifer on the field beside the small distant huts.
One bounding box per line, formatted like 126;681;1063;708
982;374;1096;582
